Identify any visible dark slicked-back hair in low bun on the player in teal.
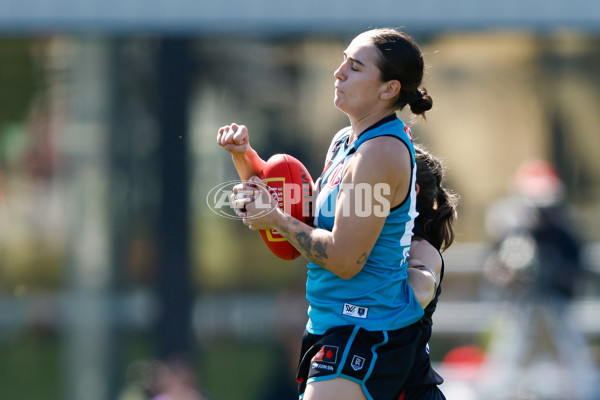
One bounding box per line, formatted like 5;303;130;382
367;28;433;118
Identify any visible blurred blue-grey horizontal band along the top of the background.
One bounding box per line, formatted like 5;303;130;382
0;0;600;34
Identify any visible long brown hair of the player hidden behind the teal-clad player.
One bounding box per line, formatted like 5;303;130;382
415;145;458;251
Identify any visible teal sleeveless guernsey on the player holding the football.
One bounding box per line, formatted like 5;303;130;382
306;115;423;334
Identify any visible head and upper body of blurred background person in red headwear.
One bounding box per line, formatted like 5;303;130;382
486;161;584;300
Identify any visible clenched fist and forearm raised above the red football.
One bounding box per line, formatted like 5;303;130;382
217;123;265;181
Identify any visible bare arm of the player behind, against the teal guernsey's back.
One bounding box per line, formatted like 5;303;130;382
408;237;442;308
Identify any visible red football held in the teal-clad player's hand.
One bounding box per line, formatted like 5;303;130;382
260;154;313;260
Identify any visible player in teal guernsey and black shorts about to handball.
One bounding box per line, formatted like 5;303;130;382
217;29;432;400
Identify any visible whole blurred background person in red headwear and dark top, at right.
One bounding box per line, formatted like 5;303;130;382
485;161;599;400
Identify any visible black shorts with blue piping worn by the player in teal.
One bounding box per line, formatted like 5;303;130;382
296;323;421;400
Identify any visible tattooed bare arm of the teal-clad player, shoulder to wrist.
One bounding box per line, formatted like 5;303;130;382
275;137;411;279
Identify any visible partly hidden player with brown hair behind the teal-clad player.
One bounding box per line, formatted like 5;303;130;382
399;146;458;400
